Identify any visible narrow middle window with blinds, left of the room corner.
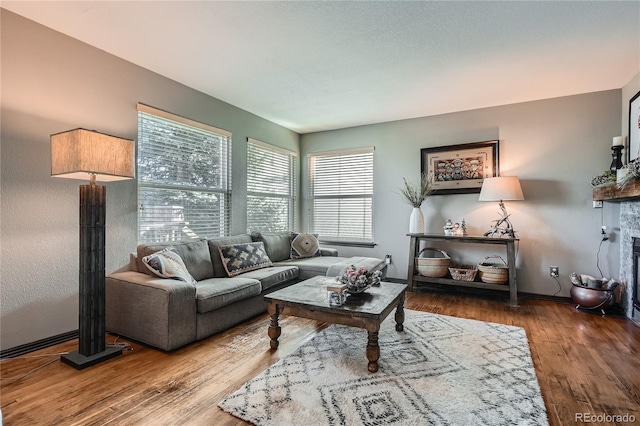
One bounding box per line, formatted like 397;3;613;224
247;138;297;232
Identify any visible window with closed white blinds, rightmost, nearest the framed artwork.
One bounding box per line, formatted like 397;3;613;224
309;148;374;245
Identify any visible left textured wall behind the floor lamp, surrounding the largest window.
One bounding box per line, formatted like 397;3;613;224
0;10;299;349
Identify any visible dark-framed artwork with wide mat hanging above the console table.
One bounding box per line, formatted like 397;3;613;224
420;140;499;195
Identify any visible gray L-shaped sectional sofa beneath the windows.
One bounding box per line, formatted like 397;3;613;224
105;232;385;351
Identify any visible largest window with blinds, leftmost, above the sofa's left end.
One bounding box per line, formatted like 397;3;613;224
138;104;231;243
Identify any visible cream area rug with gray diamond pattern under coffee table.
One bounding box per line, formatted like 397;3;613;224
219;310;548;426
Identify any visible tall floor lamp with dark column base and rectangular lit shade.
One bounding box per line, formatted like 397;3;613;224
51;129;135;370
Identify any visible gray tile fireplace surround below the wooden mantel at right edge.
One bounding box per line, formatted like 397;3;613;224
620;200;640;323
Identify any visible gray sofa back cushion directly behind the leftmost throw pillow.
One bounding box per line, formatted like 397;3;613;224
137;240;214;281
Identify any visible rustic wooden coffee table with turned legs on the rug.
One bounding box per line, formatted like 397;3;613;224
264;276;407;373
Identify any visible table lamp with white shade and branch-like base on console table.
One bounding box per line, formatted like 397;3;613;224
478;176;524;238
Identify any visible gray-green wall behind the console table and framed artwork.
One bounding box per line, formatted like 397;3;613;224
301;90;621;297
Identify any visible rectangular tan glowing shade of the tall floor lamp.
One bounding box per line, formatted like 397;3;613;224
51;129;136;182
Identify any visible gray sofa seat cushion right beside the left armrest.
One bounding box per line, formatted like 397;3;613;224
196;276;261;314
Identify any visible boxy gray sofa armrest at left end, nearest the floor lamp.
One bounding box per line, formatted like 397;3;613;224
105;271;196;351
